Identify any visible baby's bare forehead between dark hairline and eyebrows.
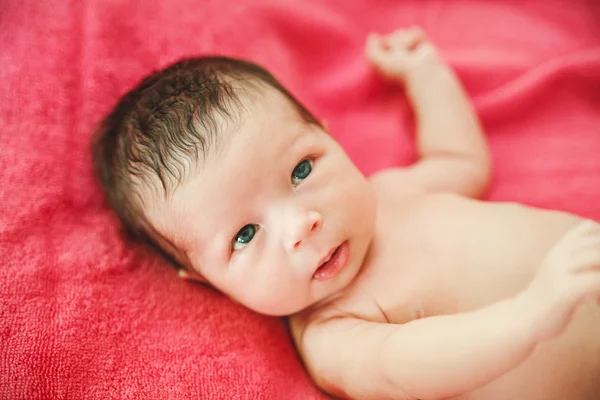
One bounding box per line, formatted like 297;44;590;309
147;89;308;248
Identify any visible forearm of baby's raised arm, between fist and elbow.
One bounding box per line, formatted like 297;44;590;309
405;60;489;168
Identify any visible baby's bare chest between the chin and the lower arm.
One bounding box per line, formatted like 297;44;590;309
354;195;580;323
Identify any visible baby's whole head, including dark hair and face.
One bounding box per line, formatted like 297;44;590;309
93;57;376;315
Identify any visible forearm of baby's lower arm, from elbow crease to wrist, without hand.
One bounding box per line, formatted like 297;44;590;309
381;299;535;399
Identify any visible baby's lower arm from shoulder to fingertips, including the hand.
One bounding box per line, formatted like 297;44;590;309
297;222;600;400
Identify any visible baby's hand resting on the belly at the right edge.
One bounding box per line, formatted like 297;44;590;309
521;221;600;340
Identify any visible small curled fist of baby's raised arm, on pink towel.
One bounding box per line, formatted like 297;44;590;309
366;27;441;82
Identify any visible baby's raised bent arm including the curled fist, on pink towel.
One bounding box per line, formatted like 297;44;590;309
367;28;491;197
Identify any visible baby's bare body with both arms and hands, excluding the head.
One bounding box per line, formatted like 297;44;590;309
290;31;600;400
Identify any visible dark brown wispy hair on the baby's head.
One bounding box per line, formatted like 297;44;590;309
92;57;318;267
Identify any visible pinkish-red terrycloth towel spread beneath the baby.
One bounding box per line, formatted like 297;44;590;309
0;0;600;399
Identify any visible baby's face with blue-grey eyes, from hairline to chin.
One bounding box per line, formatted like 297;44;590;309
145;89;376;315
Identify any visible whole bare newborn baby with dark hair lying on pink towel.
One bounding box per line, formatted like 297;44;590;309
94;28;600;400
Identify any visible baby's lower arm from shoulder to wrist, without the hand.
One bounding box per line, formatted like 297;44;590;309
301;299;535;400
